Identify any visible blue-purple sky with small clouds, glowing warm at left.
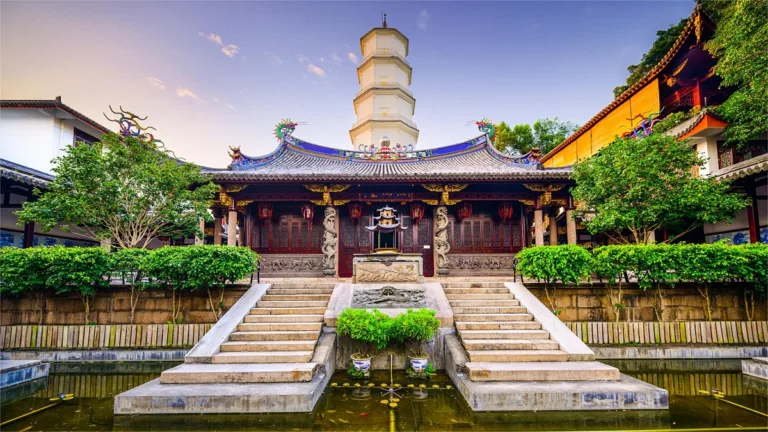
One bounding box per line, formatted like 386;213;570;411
0;0;695;167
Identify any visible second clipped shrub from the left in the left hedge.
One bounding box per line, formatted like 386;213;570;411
47;246;112;324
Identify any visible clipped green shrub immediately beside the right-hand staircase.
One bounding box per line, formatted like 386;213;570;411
517;245;591;315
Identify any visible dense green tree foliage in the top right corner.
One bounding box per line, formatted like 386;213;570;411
705;0;768;143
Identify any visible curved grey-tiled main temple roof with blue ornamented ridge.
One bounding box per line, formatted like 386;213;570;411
203;135;572;182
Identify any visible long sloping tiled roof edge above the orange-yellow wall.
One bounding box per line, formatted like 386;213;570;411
541;6;703;162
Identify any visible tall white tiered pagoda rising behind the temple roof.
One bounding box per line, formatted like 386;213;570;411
349;15;419;150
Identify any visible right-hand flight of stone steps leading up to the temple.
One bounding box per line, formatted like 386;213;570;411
442;282;619;381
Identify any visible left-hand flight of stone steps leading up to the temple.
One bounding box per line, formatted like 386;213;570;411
160;283;334;384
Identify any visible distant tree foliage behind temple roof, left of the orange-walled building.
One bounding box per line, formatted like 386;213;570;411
496;117;579;154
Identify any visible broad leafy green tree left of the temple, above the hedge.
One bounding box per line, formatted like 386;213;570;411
17;133;218;248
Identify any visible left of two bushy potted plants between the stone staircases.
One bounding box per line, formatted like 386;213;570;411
336;308;392;373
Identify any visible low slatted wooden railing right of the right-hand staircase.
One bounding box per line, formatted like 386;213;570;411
565;321;768;345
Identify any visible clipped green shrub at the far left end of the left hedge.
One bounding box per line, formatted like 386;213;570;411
0;247;50;325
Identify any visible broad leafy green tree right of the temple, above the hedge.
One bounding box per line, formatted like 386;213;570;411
573;134;747;243
